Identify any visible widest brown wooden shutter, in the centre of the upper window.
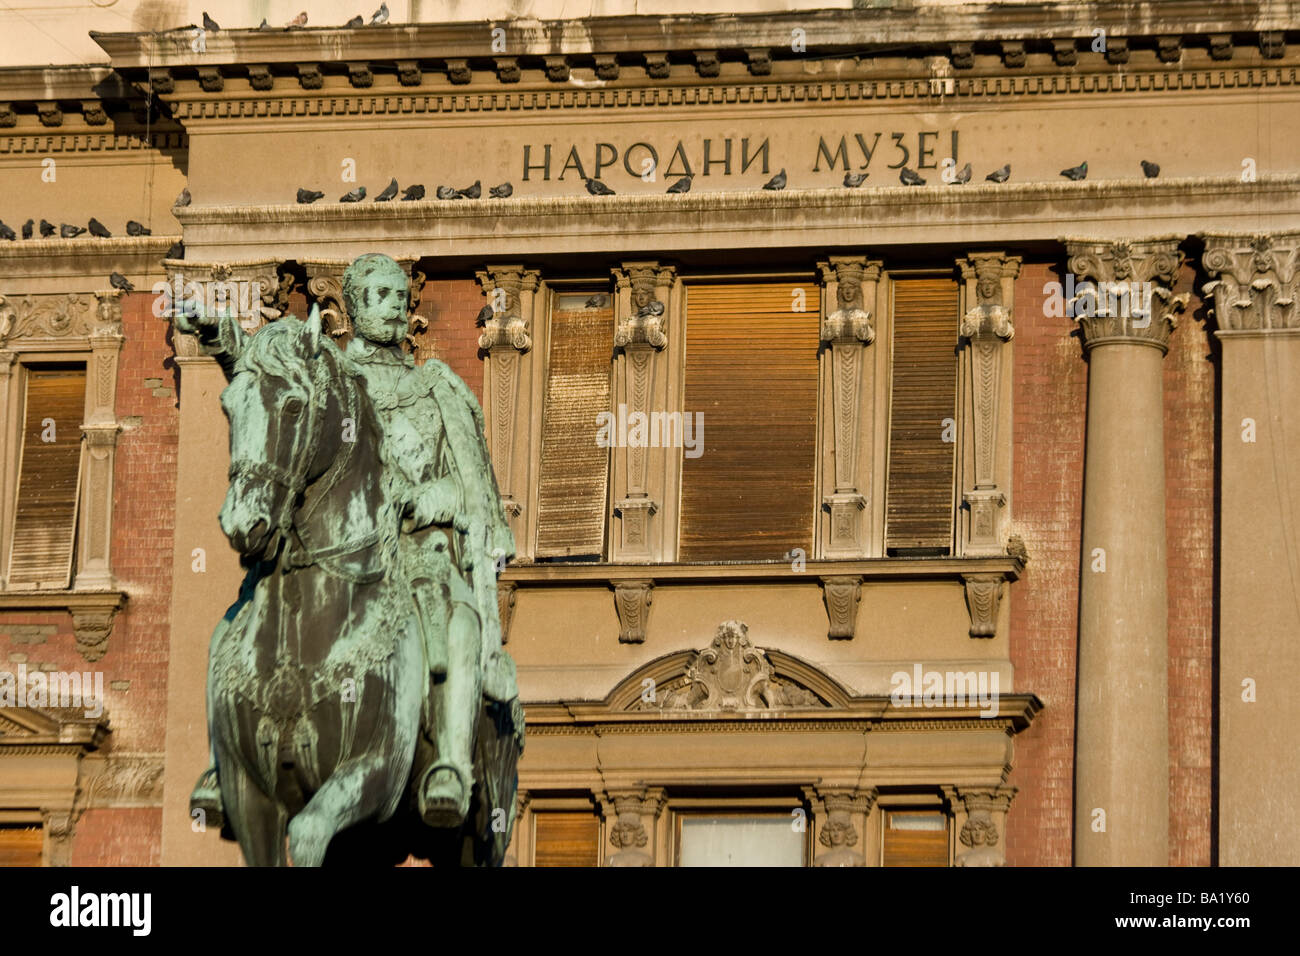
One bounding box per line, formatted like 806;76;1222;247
679;276;820;561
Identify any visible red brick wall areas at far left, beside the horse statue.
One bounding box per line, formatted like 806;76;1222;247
0;293;178;866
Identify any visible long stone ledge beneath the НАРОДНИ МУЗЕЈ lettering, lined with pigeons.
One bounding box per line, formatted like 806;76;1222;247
170;174;1300;260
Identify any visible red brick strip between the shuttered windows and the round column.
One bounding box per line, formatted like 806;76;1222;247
1006;263;1088;866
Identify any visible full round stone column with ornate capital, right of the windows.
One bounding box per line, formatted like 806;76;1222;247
1066;239;1186;866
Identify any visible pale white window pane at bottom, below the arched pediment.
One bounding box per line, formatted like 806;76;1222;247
677;813;809;866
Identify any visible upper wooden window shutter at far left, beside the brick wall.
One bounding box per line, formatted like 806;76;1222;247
9;365;86;588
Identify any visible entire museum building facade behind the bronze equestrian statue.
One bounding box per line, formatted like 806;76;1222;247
0;0;1300;866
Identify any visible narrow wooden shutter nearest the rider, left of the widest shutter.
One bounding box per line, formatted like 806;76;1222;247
537;294;614;558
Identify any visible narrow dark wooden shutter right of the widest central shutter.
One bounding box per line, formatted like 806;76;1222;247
885;278;958;554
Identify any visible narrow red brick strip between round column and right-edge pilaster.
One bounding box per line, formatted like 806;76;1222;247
1165;267;1218;866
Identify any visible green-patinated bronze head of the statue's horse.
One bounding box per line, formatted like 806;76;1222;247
221;310;342;558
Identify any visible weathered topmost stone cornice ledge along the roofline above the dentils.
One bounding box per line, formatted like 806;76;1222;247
91;0;1300;69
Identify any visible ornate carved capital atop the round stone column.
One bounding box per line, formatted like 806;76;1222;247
1062;237;1188;352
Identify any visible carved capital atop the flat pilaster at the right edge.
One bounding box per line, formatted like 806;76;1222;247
1201;233;1300;332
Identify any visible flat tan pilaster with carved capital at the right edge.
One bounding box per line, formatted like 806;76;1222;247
1203;233;1300;866
